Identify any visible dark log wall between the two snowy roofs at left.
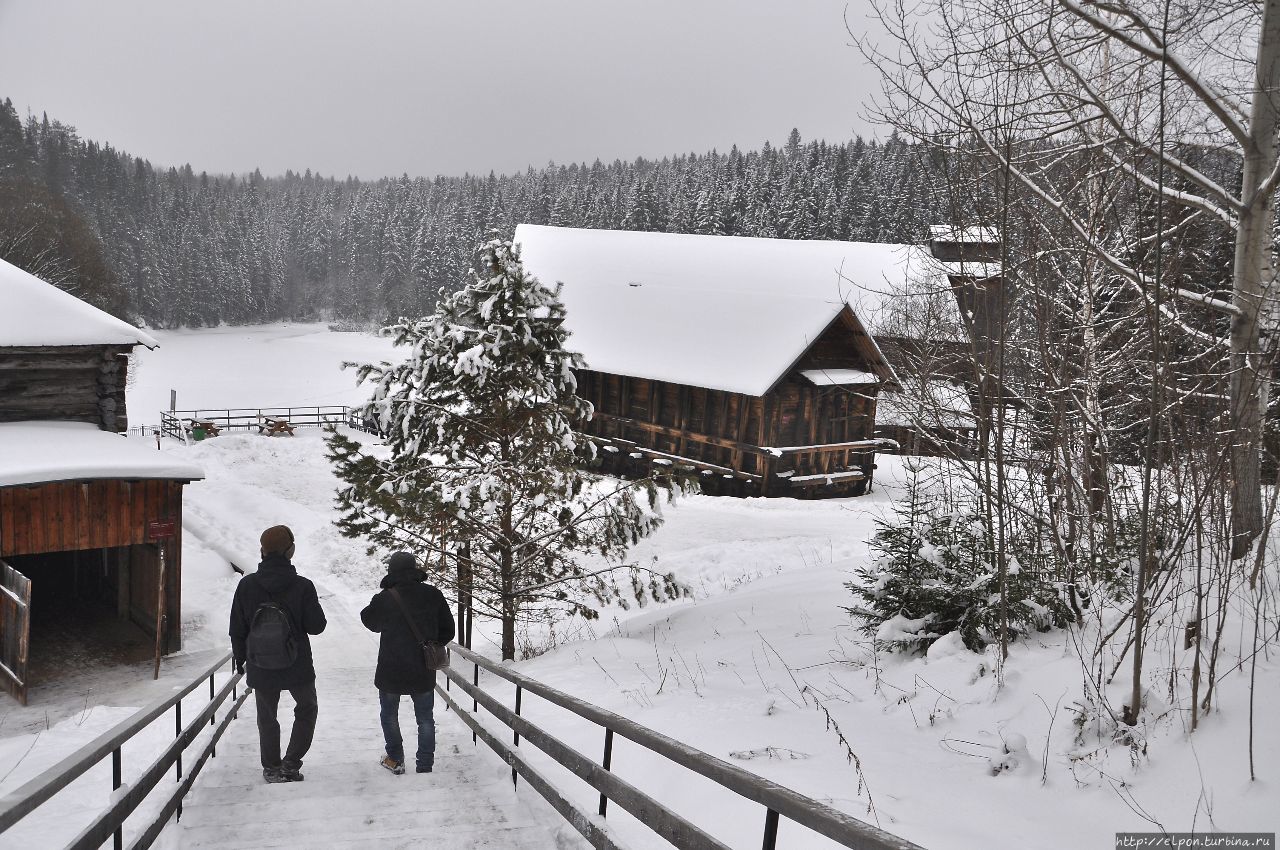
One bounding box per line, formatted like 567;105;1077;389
0;346;132;431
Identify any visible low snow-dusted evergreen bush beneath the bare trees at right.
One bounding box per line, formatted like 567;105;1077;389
846;504;1071;653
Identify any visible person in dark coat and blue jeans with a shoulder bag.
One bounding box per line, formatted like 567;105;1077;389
360;552;453;774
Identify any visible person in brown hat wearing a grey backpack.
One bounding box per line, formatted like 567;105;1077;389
230;525;328;782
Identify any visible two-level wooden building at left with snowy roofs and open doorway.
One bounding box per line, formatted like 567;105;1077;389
0;260;202;703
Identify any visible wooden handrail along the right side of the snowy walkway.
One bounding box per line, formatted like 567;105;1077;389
436;644;923;850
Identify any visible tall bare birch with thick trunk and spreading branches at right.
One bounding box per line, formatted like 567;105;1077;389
861;0;1280;559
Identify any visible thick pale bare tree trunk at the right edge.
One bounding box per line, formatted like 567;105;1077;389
1231;0;1280;559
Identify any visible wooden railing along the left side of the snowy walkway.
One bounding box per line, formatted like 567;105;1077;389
0;652;250;850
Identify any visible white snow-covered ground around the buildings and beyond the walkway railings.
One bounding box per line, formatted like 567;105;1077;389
0;325;1280;850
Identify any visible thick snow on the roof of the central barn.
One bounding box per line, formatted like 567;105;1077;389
515;224;936;396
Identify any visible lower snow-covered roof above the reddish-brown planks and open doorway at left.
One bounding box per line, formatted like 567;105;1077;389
0;421;205;486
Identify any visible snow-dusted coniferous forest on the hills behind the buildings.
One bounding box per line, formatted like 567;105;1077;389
0;100;941;328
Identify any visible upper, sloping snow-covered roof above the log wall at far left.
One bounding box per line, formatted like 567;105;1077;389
0;260;160;348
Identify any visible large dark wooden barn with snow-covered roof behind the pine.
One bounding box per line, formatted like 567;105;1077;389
515;224;928;497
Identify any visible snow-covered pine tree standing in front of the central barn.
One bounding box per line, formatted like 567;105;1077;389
328;239;685;659
